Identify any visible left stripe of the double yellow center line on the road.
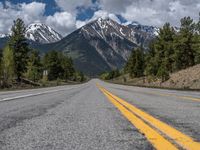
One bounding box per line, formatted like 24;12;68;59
100;88;177;150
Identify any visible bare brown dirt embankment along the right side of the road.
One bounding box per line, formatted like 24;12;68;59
113;64;200;90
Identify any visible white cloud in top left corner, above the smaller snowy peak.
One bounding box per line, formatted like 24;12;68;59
0;2;46;33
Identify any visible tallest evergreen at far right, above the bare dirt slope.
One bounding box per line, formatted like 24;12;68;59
174;17;195;70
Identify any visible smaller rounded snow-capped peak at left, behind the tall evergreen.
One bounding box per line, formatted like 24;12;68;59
26;23;62;43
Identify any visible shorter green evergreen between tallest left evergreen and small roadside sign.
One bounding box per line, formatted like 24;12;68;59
26;50;42;82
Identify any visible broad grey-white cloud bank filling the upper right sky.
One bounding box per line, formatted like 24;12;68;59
98;0;200;26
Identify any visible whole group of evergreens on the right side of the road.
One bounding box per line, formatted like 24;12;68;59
124;14;200;81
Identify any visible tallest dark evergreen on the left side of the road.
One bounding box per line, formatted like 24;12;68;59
9;18;29;81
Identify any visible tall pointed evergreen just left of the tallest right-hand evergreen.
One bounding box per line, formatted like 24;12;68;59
145;23;175;80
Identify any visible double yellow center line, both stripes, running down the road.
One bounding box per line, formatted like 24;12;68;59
97;85;200;150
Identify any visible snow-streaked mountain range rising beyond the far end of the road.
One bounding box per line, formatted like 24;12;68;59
0;18;157;76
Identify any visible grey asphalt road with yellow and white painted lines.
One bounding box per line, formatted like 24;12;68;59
0;79;200;150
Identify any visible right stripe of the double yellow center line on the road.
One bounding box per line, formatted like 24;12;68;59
100;86;200;150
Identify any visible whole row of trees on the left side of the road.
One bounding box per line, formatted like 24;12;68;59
0;18;85;87
